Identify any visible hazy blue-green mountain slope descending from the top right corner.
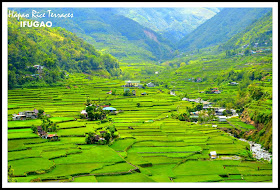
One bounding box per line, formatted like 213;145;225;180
178;8;271;51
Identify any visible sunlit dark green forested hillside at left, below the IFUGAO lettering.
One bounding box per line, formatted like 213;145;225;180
8;15;119;88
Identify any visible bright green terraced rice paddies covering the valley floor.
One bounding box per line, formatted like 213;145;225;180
8;76;272;182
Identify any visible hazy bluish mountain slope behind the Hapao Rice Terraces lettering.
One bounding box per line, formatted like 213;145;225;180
10;8;174;61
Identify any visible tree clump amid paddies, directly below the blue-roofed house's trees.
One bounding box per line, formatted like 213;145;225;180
85;125;119;144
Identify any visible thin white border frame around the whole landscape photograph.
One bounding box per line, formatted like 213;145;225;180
2;2;278;188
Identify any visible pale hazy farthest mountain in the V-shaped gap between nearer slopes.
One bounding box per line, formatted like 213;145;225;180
111;7;221;42
